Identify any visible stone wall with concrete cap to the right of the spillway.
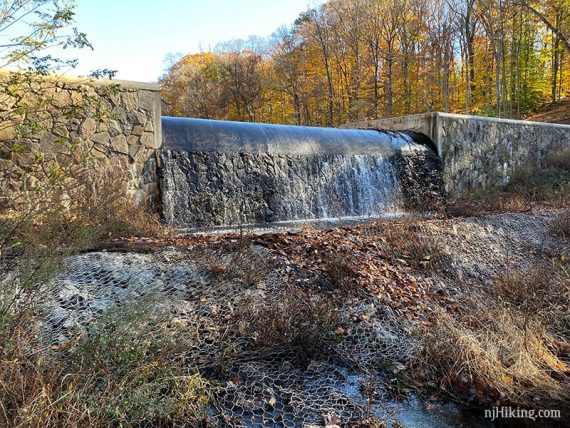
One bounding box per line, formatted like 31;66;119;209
343;113;570;194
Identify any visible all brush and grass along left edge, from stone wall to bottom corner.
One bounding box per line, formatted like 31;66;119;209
0;161;175;427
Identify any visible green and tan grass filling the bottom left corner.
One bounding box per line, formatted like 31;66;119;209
0;304;214;427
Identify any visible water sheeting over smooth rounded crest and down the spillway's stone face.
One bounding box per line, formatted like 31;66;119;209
160;117;441;228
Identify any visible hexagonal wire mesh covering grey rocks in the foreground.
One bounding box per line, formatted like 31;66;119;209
35;245;434;428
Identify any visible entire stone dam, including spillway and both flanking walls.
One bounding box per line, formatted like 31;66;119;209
0;78;570;231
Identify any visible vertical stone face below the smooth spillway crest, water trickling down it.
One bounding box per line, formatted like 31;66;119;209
160;149;440;229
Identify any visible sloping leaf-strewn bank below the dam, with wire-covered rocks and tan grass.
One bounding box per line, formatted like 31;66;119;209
25;209;570;427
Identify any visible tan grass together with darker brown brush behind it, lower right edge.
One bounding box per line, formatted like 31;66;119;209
415;260;570;409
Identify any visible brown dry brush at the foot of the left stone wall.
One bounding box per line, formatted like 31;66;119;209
0;162;167;350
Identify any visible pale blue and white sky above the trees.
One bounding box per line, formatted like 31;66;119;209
64;0;322;82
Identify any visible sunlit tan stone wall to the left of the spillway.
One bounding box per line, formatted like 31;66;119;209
0;73;162;208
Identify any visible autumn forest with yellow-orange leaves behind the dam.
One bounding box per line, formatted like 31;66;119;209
161;0;570;126
